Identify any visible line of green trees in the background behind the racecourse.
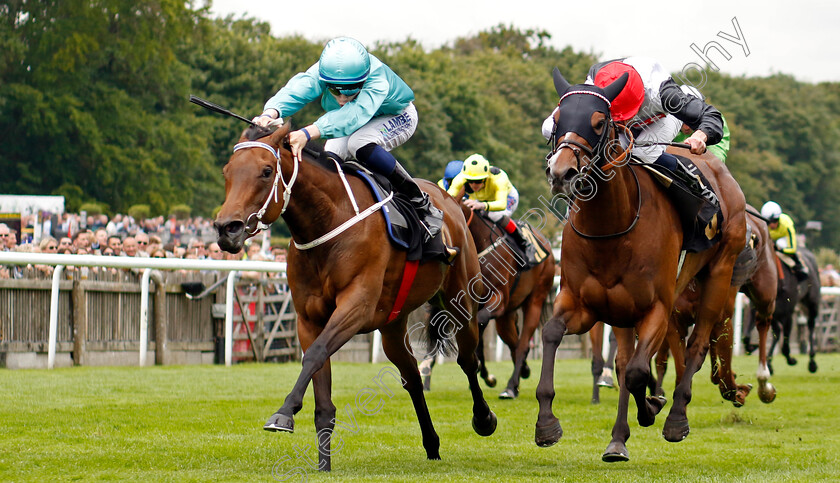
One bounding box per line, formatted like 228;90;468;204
0;0;840;249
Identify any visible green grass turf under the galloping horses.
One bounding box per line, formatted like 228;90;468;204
0;354;840;482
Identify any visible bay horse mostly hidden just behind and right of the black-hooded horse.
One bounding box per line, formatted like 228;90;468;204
655;206;778;407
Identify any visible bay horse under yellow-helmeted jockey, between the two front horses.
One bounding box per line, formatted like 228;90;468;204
467;211;554;399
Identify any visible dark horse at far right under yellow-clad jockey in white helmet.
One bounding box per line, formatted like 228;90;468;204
759;247;821;373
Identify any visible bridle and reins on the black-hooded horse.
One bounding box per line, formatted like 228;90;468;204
546;100;642;239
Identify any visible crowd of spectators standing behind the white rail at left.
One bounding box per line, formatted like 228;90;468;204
0;213;286;278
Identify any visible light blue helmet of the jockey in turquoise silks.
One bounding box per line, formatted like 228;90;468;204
318;37;370;87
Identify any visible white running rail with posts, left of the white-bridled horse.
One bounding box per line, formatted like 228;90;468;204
0;252;286;369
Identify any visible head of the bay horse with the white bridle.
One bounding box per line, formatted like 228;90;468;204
214;123;291;253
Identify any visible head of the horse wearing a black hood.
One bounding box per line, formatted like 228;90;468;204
546;68;628;196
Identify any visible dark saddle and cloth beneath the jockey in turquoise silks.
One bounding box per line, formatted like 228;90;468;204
319;152;451;263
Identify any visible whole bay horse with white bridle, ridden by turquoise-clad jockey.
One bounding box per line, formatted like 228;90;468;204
215;122;496;471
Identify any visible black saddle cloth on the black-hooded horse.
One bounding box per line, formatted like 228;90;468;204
642;155;723;253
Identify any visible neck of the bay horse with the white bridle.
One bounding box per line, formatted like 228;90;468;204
278;160;348;243
